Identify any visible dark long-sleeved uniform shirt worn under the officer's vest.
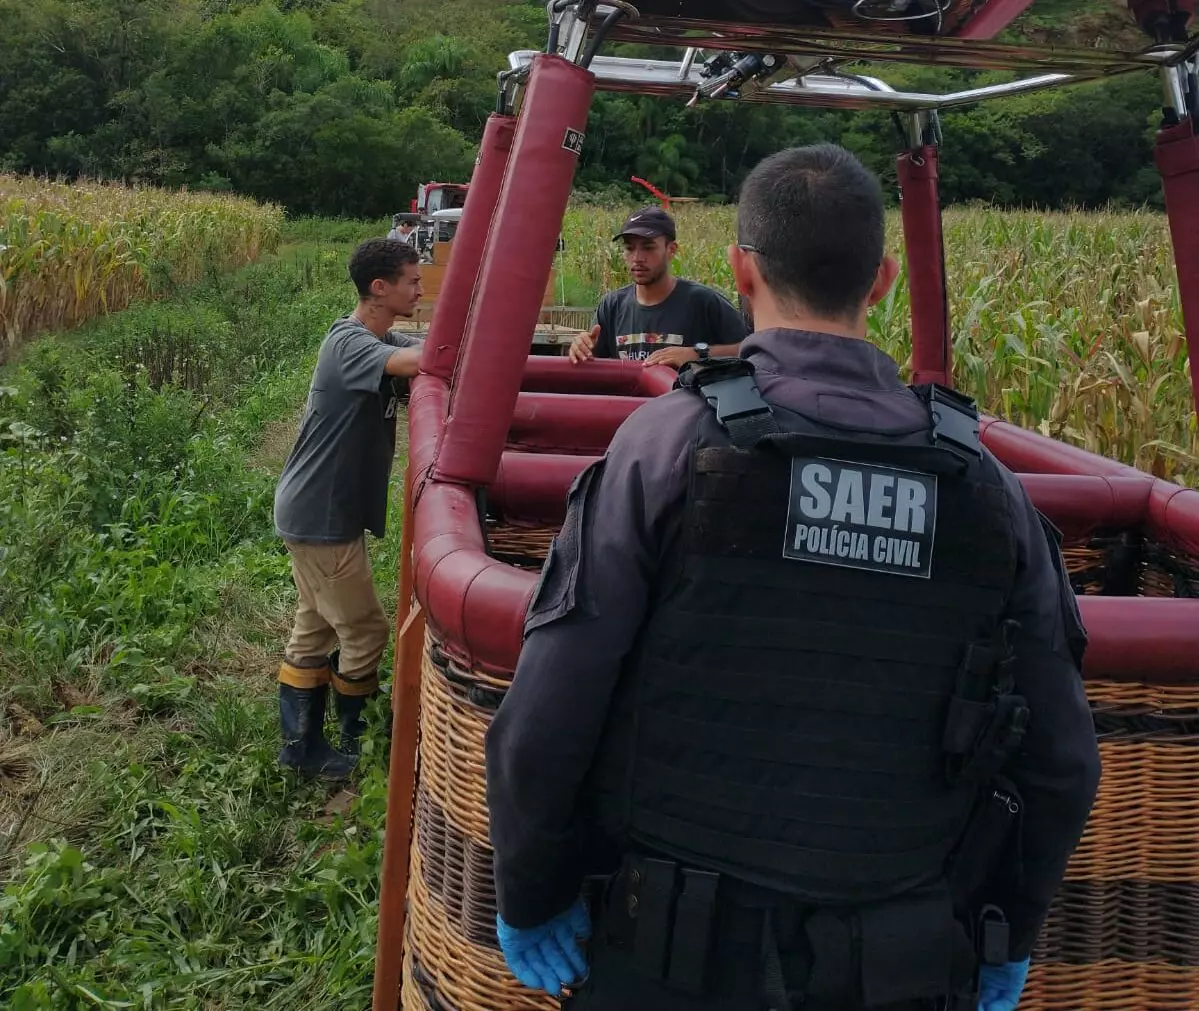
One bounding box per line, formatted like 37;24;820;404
487;330;1099;958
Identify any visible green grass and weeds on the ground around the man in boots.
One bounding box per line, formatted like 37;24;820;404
0;241;404;1011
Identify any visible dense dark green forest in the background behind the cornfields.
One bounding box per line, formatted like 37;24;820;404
0;0;1179;216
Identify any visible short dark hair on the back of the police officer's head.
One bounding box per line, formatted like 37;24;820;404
737;144;884;318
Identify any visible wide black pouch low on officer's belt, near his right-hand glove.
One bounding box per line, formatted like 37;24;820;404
805;879;976;1009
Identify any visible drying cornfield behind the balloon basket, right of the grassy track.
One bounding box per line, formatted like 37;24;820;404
560;205;1199;486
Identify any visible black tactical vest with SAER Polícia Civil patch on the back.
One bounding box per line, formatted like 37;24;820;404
589;359;1028;905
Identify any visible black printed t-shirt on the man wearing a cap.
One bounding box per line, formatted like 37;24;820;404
594;277;746;361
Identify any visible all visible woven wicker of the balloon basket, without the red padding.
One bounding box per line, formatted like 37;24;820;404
403;520;1199;1011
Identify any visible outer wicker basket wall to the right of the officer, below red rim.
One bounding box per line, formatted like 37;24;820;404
1020;681;1199;1011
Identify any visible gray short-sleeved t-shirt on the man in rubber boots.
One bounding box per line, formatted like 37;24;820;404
275;317;422;543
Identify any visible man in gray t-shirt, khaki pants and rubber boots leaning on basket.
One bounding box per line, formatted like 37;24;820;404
275;239;422;780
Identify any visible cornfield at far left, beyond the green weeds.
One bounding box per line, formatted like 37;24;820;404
0;175;283;359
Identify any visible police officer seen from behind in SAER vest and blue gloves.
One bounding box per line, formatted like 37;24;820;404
487;145;1099;1011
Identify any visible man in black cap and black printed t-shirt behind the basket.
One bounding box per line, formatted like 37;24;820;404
570;207;746;368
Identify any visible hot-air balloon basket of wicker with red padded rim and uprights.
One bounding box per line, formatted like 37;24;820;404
373;0;1199;1011
